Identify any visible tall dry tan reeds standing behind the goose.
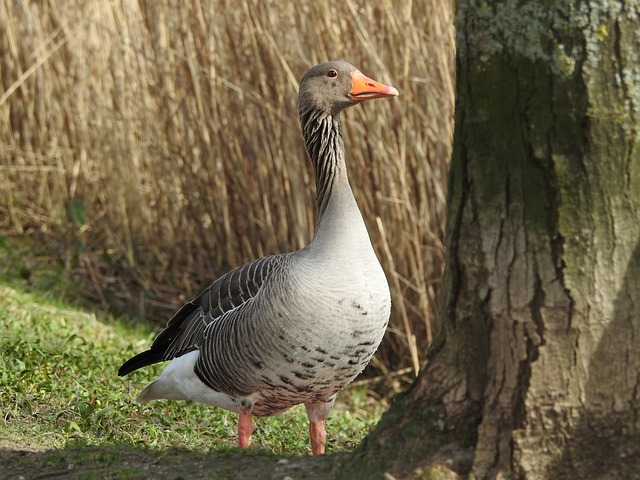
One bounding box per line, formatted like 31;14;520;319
0;0;454;390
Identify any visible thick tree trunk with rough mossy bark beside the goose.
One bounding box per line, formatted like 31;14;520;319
343;0;640;479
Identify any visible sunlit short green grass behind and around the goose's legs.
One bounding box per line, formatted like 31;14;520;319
0;277;383;454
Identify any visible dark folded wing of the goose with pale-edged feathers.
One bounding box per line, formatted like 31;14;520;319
118;254;287;376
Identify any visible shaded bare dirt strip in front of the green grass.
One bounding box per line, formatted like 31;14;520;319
0;440;347;480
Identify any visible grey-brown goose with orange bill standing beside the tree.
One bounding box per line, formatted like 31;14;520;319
118;60;398;455
